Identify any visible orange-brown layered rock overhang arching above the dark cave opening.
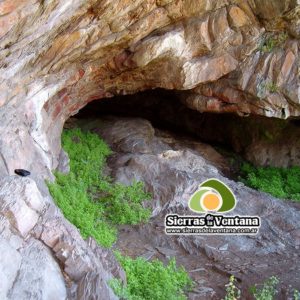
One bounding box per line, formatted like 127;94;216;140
0;0;300;176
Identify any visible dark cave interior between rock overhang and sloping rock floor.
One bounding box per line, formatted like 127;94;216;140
76;89;300;164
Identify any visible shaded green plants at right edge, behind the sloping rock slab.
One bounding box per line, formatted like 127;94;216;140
241;163;300;201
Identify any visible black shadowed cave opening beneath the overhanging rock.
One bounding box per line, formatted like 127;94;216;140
75;89;300;167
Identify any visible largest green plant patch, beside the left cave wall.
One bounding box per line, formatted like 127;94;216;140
48;129;150;247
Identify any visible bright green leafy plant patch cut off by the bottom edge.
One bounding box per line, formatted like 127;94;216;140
110;253;193;300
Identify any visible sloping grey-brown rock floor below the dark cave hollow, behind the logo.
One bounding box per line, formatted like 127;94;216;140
81;117;300;299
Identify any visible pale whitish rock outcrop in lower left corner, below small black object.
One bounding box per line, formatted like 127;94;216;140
0;176;122;300
